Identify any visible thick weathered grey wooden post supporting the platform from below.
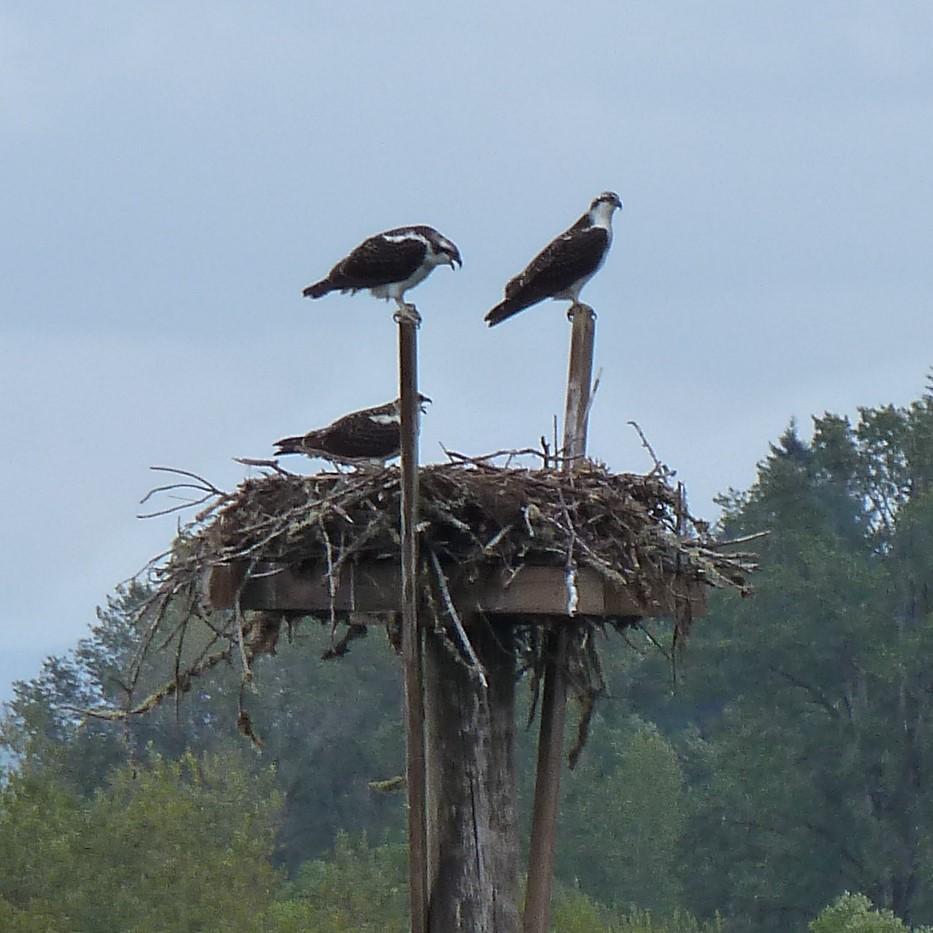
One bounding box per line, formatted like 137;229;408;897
425;615;518;933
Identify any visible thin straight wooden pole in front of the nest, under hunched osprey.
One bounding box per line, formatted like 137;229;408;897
398;318;428;933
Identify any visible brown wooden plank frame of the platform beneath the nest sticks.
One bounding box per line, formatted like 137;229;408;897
205;561;706;618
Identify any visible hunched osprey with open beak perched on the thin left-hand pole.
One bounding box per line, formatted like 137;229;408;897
302;226;463;321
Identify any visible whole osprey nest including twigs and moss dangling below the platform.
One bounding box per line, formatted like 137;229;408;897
109;458;755;764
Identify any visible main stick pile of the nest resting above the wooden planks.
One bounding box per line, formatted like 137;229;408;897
195;461;752;589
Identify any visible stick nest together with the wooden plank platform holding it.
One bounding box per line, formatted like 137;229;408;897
197;462;748;621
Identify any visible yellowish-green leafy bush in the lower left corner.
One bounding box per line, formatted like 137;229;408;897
0;755;280;933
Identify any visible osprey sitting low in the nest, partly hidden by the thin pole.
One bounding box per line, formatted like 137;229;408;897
275;395;431;466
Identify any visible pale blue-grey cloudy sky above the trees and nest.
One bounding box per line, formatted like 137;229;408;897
0;0;933;699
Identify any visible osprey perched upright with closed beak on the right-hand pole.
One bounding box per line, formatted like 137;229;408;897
486;191;622;327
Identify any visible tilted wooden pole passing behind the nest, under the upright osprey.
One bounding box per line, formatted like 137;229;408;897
524;304;596;933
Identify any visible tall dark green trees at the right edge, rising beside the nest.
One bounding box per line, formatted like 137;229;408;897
672;397;933;931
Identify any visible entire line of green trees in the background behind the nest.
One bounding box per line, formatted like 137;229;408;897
0;384;933;933
